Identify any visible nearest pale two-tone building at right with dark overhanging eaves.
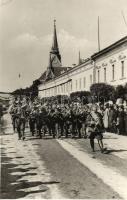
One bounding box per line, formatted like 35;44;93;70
91;36;127;86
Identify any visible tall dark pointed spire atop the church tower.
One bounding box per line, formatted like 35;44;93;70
50;20;61;62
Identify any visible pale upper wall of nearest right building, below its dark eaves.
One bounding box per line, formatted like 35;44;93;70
95;45;127;86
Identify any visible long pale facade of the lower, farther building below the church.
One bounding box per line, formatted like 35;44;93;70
39;60;94;98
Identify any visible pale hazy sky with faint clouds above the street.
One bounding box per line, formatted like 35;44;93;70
0;0;127;92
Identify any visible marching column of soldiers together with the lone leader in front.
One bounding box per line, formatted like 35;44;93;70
10;98;127;152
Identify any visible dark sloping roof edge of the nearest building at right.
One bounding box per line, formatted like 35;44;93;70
91;36;127;60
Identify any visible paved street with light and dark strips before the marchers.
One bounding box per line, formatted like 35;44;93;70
1;115;127;199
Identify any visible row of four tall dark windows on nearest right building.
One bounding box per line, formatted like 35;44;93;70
97;61;125;83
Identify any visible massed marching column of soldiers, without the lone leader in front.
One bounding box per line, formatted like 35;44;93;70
10;99;88;139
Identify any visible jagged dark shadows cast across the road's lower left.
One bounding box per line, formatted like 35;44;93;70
1;148;59;199
